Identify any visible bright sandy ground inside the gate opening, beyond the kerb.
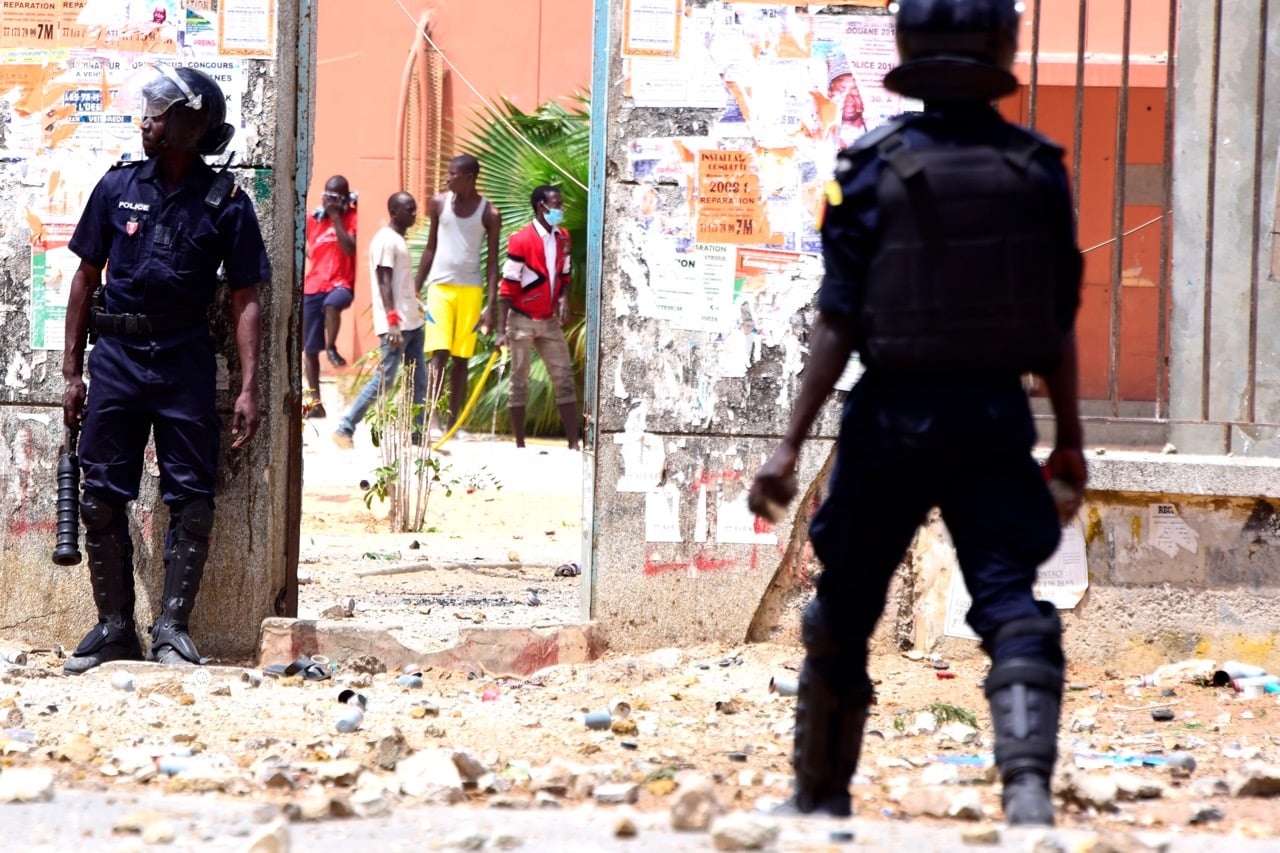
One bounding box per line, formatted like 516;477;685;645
298;384;584;651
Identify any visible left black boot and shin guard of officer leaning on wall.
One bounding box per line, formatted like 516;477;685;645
63;493;142;675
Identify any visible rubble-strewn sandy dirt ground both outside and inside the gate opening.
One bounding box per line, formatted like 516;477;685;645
0;379;1280;845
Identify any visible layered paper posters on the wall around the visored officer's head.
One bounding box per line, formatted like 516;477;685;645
0;0;276;351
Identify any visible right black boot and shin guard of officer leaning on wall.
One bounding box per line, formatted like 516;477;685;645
148;500;214;666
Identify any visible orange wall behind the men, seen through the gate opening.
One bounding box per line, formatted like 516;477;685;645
307;0;593;370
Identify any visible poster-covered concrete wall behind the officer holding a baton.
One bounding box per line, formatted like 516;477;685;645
0;0;294;657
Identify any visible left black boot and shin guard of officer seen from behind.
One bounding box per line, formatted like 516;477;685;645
773;599;872;817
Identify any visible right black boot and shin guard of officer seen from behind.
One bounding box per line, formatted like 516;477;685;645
984;602;1064;826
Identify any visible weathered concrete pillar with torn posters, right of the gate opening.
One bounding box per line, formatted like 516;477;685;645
588;0;870;648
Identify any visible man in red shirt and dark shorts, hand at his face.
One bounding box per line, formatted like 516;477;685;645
302;174;356;418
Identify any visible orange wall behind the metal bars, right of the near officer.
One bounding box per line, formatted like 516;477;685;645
1002;0;1174;401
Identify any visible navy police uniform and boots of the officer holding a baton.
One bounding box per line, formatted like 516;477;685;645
64;156;271;674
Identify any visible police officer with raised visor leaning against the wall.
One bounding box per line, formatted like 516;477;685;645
63;65;270;674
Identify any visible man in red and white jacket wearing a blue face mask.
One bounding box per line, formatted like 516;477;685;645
497;186;579;450
